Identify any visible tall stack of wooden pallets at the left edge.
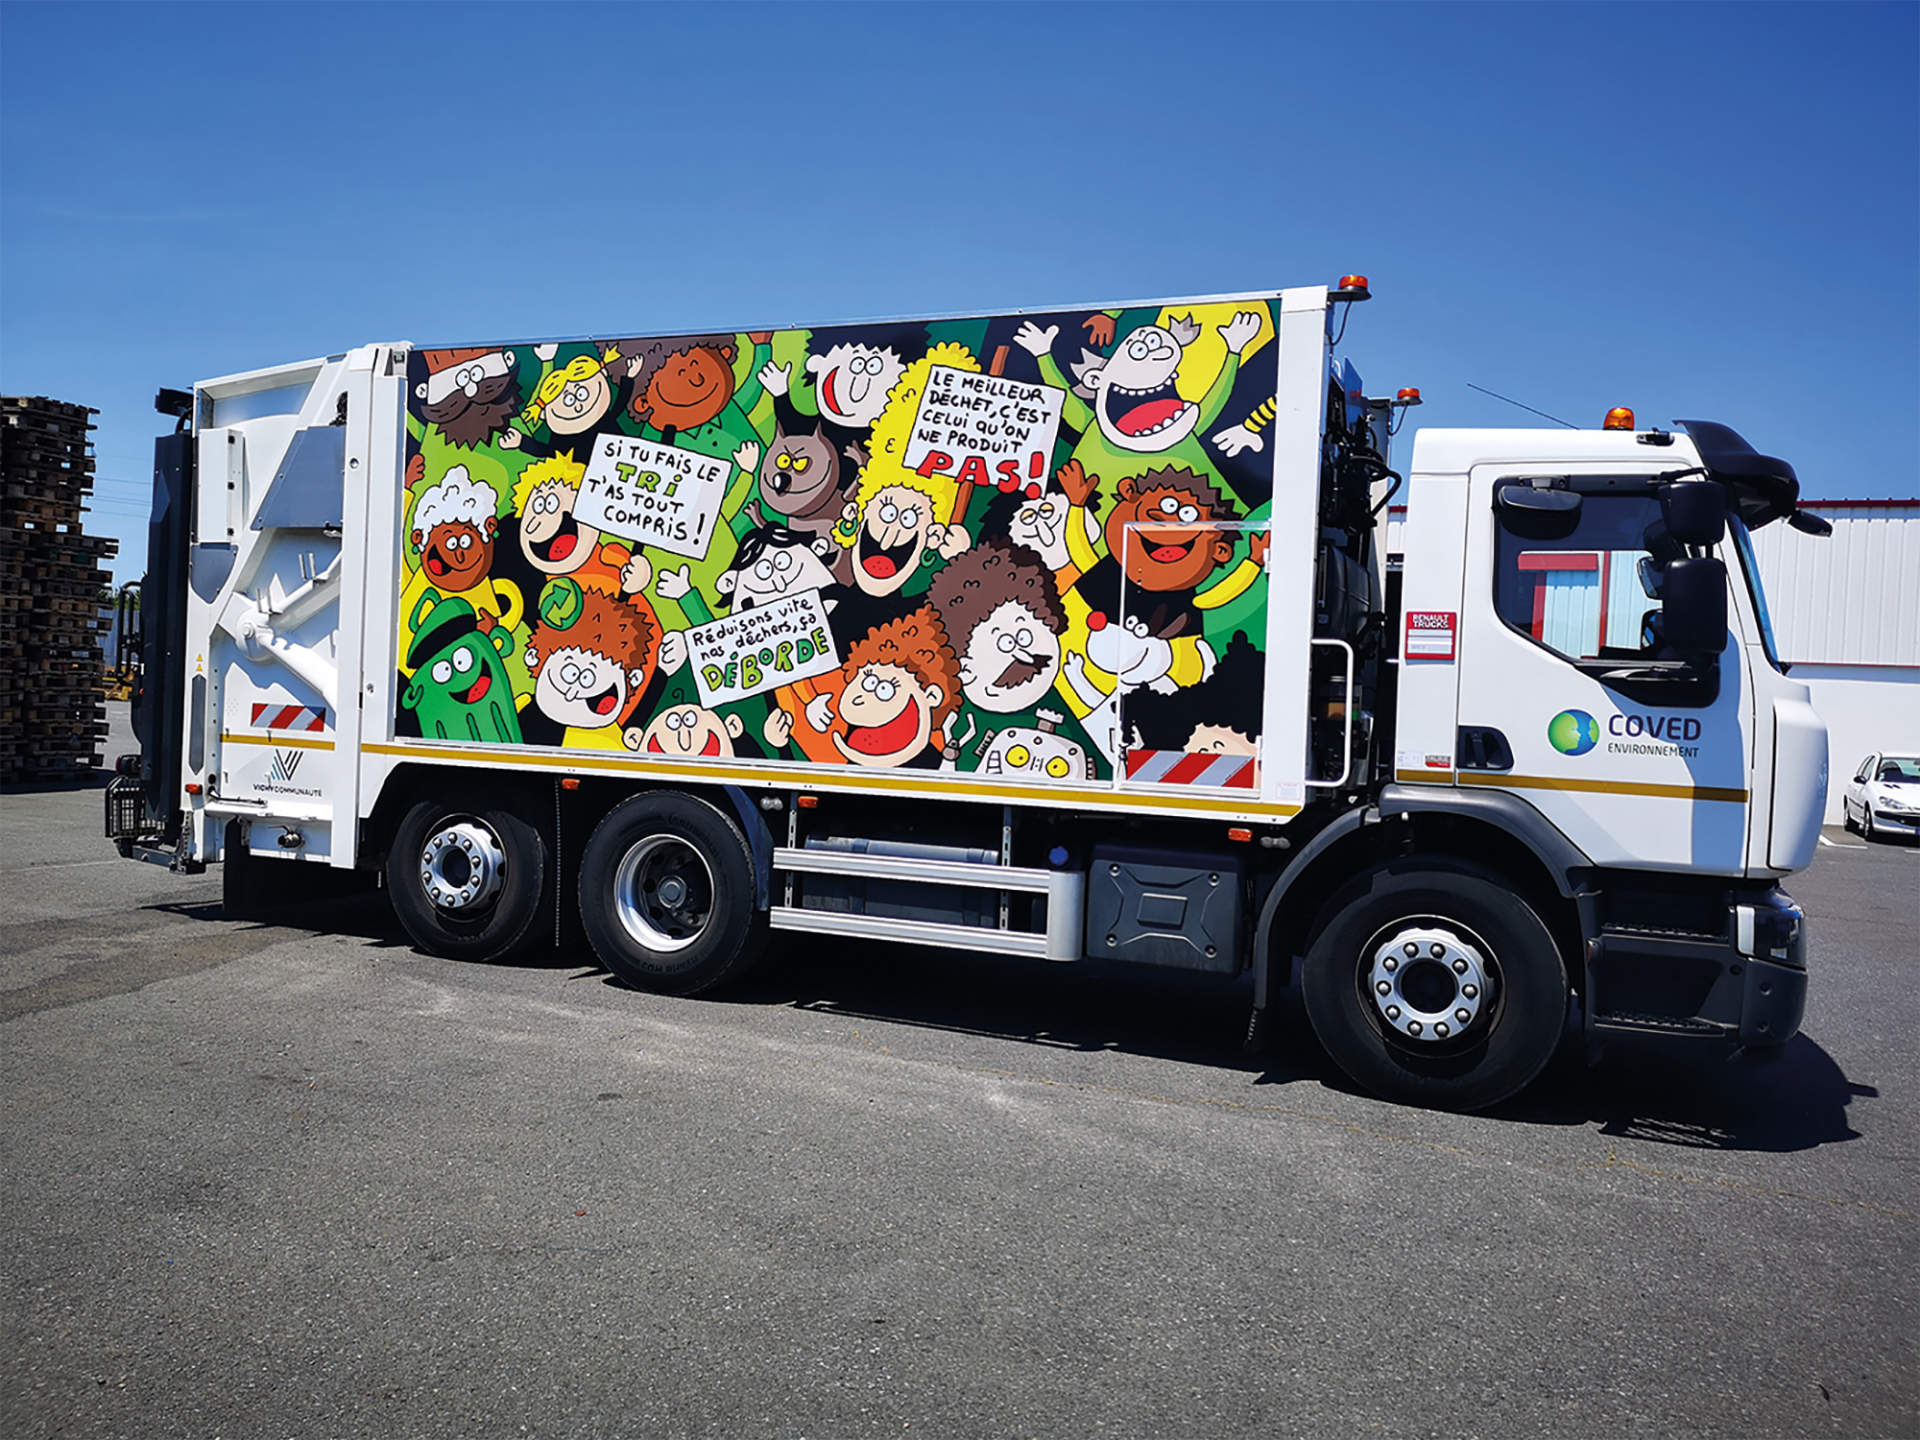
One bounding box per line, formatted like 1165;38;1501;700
0;396;119;783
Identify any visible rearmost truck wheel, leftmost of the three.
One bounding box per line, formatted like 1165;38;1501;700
386;799;547;962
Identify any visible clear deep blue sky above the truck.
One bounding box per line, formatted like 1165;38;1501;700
0;0;1920;578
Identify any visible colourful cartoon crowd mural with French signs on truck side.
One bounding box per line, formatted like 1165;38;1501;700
396;298;1277;787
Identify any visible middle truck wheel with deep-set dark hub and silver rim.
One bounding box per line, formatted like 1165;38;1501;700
580;791;766;995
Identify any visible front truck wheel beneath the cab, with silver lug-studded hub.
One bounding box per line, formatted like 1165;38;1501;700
1300;860;1567;1110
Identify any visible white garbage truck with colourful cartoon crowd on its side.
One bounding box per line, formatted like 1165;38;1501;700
106;276;1826;1108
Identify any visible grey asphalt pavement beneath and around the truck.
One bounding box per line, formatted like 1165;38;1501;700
0;714;1920;1440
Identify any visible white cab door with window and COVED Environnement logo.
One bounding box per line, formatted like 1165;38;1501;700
1453;467;1753;872
